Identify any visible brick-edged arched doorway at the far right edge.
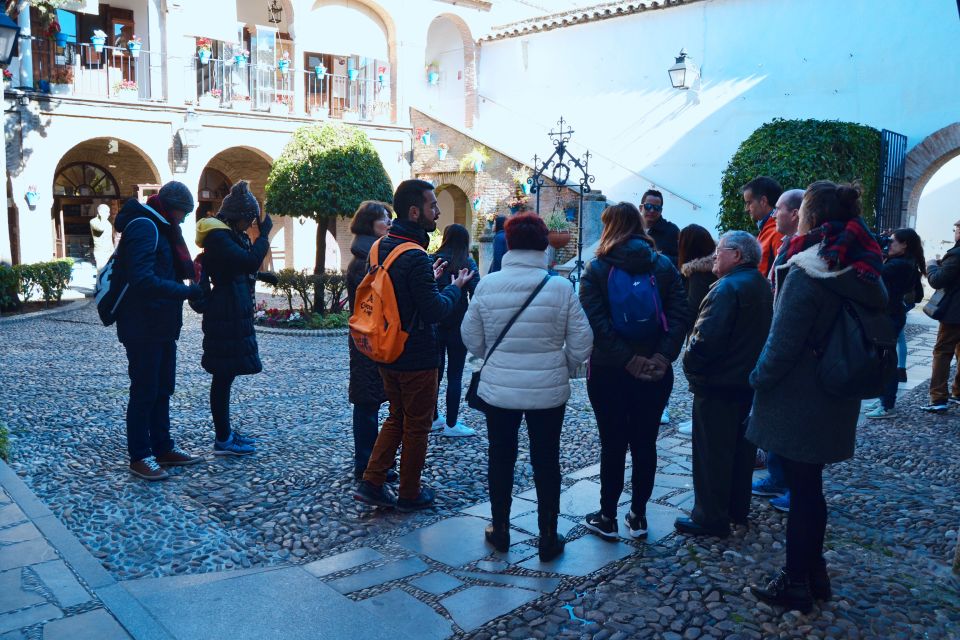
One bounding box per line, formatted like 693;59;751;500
903;122;960;258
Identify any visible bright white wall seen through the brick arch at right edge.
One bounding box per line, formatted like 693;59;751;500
917;156;960;259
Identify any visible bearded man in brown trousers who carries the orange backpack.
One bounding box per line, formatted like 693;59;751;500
354;180;473;511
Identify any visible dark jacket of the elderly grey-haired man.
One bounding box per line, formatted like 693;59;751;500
683;264;773;393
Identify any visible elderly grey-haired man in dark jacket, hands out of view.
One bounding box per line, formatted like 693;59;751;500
674;231;773;537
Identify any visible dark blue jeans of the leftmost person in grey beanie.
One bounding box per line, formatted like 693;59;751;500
123;340;177;462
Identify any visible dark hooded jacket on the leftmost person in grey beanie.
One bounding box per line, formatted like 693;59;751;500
116;198;190;343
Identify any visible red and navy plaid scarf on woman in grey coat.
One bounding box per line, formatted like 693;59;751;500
787;216;883;280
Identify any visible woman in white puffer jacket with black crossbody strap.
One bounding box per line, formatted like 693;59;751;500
460;214;593;562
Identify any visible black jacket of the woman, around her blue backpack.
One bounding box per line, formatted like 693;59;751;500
580;236;690;367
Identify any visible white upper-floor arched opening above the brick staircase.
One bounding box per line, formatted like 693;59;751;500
424;13;477;129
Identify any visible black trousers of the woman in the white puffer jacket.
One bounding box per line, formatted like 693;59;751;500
487;404;567;522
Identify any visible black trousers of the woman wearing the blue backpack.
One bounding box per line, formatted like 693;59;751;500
587;367;673;518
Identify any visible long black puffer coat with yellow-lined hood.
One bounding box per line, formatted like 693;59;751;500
198;228;270;376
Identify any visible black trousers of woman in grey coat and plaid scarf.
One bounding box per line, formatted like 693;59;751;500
780;456;827;580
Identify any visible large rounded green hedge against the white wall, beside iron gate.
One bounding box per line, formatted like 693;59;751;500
717;118;880;232
